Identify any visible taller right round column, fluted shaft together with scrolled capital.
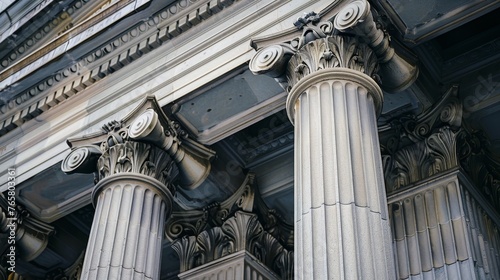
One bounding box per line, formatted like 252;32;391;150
250;1;418;279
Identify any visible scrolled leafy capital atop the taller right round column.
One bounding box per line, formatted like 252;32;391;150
249;0;418;92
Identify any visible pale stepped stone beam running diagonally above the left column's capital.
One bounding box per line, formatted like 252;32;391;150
0;0;312;197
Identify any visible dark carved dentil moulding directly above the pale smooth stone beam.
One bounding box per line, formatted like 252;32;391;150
0;0;242;135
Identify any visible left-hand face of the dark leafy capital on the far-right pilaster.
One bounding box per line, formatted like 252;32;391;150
379;86;469;193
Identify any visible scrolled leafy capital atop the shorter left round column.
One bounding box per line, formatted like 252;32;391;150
61;96;214;192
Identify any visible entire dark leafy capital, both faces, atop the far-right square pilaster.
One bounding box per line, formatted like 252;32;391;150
379;83;500;210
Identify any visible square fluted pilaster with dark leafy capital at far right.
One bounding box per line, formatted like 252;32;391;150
380;86;500;279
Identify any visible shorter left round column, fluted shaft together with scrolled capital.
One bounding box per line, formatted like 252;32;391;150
62;97;213;280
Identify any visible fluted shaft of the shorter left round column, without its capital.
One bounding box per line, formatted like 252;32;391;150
81;173;171;279
